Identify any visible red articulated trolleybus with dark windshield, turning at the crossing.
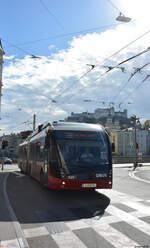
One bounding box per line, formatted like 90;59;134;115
19;122;112;190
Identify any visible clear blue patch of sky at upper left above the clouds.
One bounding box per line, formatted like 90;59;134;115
0;0;113;57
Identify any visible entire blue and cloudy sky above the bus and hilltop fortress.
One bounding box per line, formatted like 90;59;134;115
0;0;150;135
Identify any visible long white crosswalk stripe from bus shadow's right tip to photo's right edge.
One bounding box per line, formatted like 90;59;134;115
107;206;150;235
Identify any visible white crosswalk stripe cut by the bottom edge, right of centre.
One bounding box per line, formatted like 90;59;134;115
94;224;138;248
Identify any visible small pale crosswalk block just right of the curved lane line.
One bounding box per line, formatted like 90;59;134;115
23;226;49;238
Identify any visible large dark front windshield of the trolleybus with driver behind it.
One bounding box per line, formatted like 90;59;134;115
56;131;109;174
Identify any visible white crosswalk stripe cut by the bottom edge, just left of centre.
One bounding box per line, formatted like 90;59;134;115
52;231;87;248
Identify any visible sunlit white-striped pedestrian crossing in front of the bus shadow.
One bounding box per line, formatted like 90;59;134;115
1;190;150;248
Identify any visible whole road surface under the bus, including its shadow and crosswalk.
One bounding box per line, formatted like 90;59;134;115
0;165;150;248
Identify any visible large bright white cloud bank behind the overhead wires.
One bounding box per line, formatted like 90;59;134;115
2;13;150;133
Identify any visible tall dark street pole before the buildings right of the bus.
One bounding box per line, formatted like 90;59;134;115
131;115;139;170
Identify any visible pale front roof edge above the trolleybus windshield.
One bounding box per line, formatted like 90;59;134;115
53;122;104;131
